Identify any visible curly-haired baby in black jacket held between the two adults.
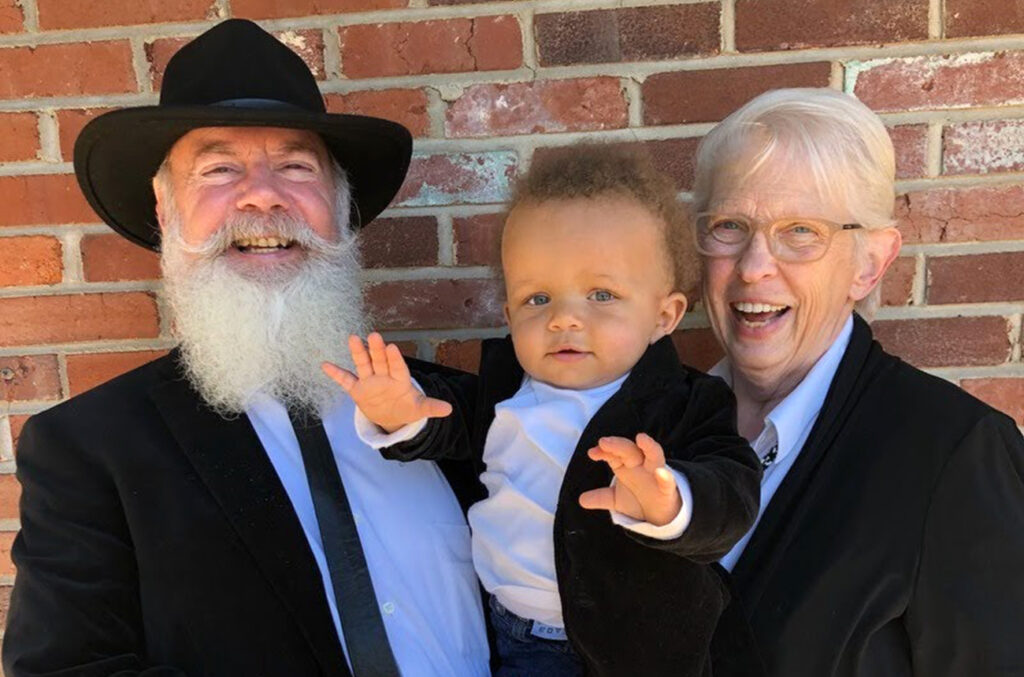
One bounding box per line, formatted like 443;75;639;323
325;145;761;677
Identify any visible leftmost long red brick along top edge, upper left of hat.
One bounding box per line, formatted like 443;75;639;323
36;0;217;31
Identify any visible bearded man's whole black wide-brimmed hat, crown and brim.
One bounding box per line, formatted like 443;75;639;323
75;18;413;249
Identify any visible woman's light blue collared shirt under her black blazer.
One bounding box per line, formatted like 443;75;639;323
708;315;853;572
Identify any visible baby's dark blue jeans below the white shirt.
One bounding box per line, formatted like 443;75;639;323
490;595;584;677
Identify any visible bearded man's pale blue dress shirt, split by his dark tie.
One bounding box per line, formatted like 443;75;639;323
246;393;490;677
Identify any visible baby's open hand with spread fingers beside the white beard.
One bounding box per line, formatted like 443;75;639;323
323;332;452;432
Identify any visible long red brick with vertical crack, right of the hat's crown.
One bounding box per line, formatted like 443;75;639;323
340;16;522;78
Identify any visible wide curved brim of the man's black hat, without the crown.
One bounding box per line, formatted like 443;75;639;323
75;105;413;251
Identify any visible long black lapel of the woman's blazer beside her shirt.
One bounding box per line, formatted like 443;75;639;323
732;315;883;609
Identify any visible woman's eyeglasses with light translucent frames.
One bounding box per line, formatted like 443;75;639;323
694;212;864;263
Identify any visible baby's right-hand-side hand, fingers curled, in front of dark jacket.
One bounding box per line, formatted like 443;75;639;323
580;432;683;526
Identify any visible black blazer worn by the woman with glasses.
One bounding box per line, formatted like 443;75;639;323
716;316;1024;677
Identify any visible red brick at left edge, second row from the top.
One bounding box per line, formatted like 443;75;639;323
0;40;136;98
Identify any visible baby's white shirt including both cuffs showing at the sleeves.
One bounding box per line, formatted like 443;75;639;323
355;376;692;628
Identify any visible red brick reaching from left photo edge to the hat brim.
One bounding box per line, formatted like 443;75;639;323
0;174;99;226
